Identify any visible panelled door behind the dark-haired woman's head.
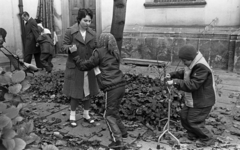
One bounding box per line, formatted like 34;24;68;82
69;0;96;31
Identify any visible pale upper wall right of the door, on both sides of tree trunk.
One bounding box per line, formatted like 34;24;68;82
101;0;240;29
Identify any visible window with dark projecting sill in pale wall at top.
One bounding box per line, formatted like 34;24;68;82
144;0;207;7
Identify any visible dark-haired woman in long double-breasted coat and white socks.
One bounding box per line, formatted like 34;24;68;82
62;8;99;127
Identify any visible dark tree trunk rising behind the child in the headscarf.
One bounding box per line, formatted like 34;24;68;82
111;0;127;55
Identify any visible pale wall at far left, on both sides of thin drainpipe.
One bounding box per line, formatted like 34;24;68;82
0;0;38;56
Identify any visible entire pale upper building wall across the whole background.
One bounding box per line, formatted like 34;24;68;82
0;0;240;65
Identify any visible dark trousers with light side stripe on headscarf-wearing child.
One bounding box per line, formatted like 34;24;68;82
104;86;127;142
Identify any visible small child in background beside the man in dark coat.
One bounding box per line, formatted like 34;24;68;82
37;24;54;74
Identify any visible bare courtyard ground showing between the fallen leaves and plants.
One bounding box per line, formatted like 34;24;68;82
22;55;240;150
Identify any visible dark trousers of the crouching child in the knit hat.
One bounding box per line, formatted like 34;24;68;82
180;106;213;141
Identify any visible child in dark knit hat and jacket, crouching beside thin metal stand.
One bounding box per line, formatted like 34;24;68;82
167;45;216;147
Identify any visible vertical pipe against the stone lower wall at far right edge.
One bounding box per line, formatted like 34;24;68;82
227;34;237;72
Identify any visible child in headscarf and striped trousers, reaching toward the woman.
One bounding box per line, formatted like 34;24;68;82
70;33;128;149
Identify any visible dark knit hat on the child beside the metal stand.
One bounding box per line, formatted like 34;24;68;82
178;44;197;60
